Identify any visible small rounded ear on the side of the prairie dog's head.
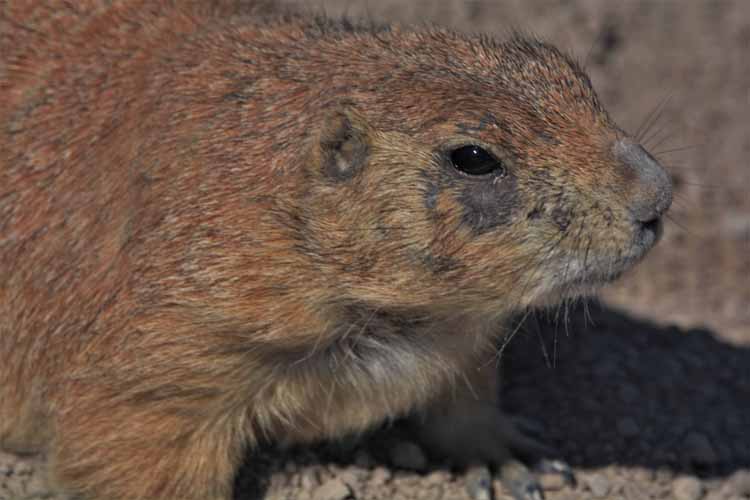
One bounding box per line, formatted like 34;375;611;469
314;104;373;182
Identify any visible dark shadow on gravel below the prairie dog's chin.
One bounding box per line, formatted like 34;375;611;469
503;300;750;477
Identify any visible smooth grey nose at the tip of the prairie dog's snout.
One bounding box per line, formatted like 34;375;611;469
614;139;672;223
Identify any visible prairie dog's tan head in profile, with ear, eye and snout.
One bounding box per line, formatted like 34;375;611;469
296;32;672;312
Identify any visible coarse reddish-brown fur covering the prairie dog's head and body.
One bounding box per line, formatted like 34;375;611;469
0;0;671;500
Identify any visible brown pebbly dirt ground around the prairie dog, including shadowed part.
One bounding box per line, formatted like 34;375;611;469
0;0;750;500
